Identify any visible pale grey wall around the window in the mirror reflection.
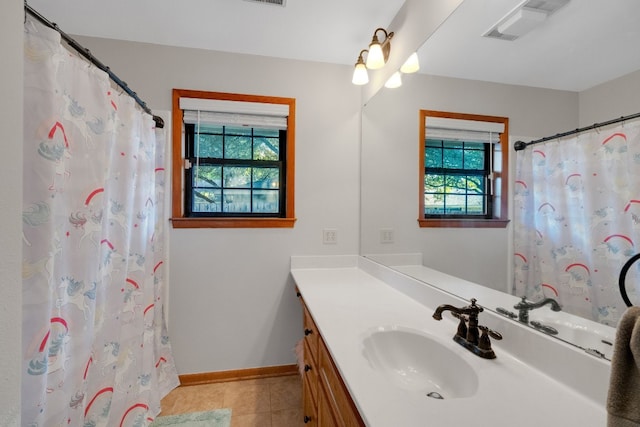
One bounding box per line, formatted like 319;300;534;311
361;75;578;290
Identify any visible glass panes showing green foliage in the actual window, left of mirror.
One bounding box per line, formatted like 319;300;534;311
185;124;287;217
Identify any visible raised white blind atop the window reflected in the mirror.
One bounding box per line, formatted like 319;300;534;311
426;117;504;143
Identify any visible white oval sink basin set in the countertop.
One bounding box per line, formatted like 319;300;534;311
363;327;478;399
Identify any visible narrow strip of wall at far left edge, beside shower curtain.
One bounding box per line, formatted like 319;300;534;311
0;0;24;427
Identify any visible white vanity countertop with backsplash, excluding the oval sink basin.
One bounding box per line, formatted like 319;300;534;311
291;258;606;427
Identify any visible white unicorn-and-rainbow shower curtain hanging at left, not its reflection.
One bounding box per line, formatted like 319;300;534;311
23;18;178;426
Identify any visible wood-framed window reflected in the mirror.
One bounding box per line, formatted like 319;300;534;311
418;110;509;228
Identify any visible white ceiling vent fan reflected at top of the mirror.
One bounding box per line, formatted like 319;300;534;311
483;0;569;41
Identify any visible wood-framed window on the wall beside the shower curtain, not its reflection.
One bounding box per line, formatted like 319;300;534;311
172;89;295;228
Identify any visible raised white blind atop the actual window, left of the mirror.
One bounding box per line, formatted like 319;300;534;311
180;98;289;129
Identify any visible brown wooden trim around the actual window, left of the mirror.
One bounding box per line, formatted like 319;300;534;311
171;89;296;228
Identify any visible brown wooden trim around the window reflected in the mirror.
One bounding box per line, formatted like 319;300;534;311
418;110;509;228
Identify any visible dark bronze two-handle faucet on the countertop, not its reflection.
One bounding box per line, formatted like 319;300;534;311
433;298;502;359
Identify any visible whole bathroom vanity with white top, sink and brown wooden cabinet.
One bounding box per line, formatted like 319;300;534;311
291;255;610;427
